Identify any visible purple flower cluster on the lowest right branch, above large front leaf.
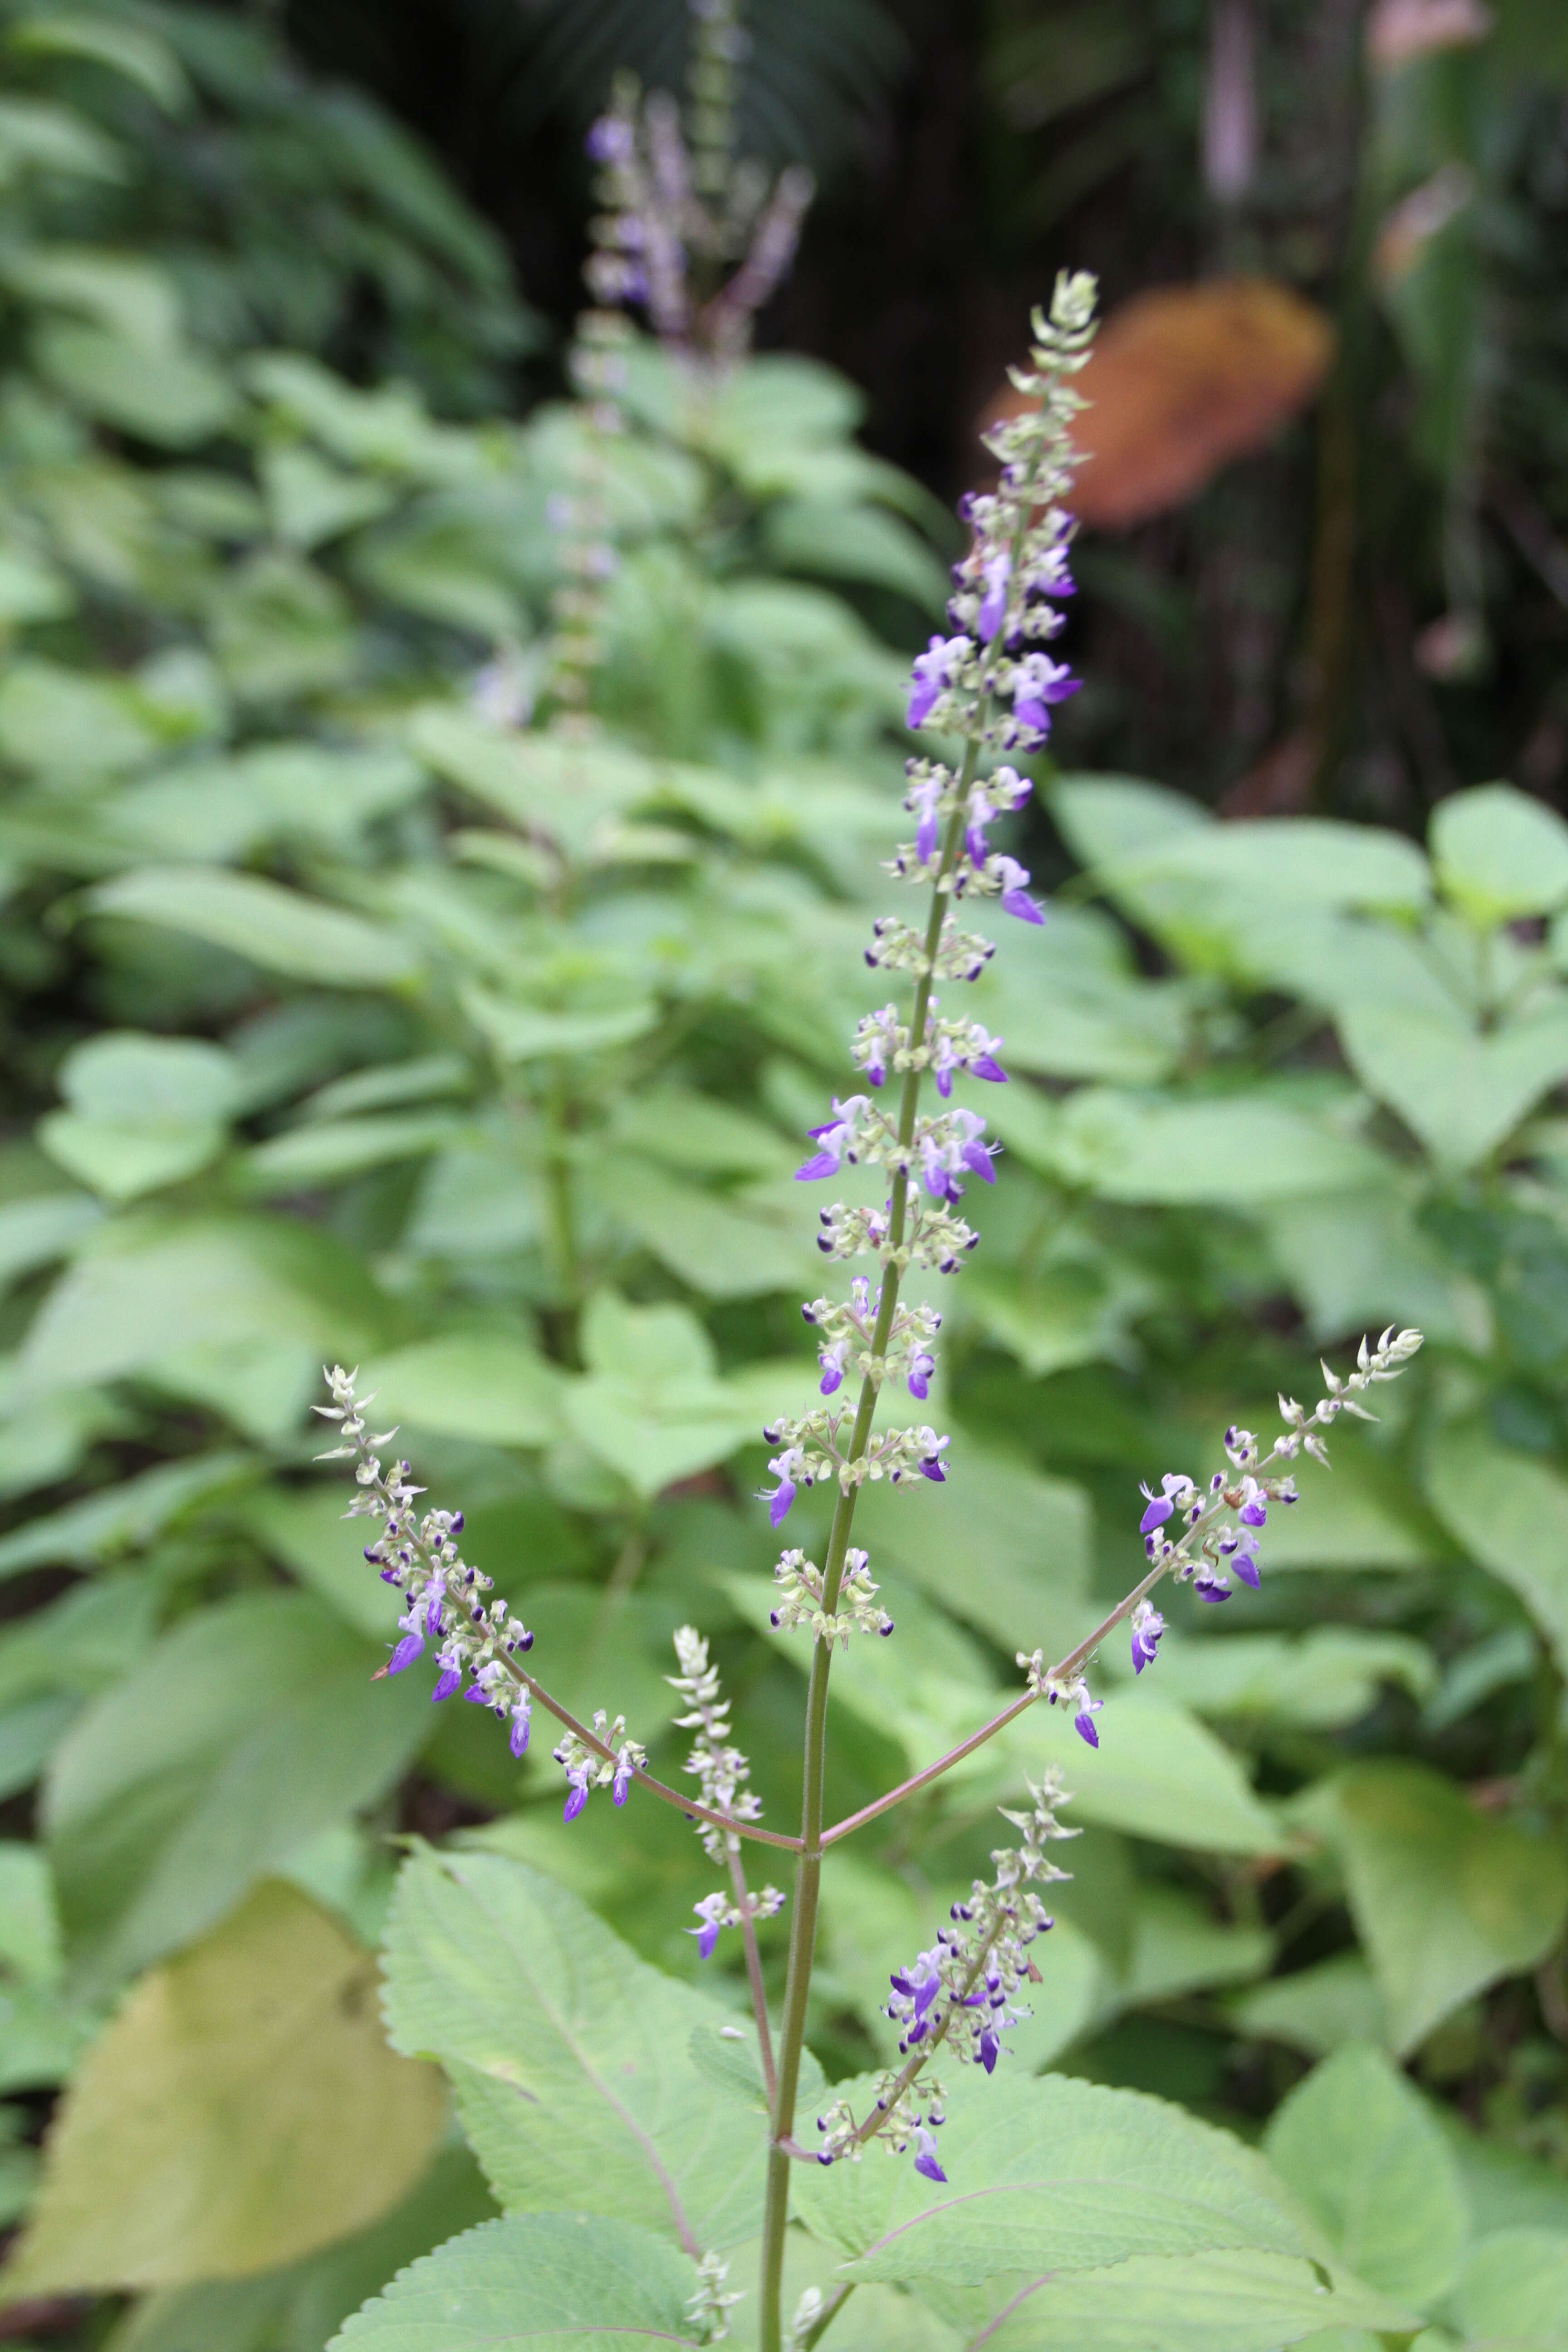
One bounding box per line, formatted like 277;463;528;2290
818;1769;1079;2180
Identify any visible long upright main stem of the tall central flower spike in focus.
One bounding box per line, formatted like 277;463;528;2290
760;741;980;2352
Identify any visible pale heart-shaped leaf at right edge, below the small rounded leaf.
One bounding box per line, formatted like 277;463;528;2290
1340;990;1568;1169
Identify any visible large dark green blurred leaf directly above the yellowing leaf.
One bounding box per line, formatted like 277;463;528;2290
42;1592;432;1980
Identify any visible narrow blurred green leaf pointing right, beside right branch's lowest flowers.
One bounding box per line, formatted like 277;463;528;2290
1112;1637;1436;1731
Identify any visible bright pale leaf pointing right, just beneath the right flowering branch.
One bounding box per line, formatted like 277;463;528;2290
999;1689;1288;1853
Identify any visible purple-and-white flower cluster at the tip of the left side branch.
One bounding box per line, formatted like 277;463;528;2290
315;1364;534;1757
